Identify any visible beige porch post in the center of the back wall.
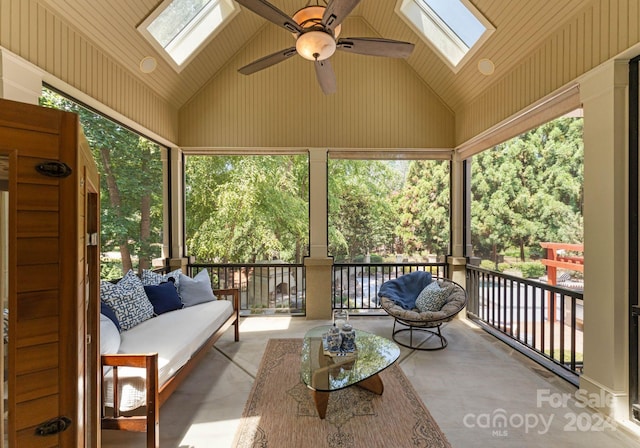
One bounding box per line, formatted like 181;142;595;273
304;148;333;319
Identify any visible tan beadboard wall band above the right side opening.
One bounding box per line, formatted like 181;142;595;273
456;0;640;145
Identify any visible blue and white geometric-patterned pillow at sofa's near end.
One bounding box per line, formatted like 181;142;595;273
100;270;153;331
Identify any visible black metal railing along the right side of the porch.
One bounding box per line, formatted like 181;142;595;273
467;266;583;385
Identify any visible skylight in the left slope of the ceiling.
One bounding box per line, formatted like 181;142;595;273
138;0;239;71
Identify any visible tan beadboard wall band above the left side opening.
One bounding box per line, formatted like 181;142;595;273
0;0;178;142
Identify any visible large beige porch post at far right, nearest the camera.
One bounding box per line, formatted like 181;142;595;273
580;61;637;420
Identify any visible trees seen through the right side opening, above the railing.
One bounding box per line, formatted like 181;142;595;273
471;114;584;279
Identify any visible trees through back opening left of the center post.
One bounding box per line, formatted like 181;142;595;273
185;155;309;263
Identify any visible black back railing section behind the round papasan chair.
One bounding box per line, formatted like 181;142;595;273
331;263;448;315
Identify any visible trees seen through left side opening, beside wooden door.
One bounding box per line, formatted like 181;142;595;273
40;88;164;279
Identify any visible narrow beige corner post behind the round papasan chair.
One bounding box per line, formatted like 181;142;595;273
447;152;467;287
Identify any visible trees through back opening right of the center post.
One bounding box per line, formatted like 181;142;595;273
328;159;449;263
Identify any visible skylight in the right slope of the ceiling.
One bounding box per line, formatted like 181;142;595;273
396;0;495;72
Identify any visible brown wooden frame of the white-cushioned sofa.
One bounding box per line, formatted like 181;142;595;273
100;289;240;448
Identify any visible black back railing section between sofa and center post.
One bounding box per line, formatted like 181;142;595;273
187;263;306;315
